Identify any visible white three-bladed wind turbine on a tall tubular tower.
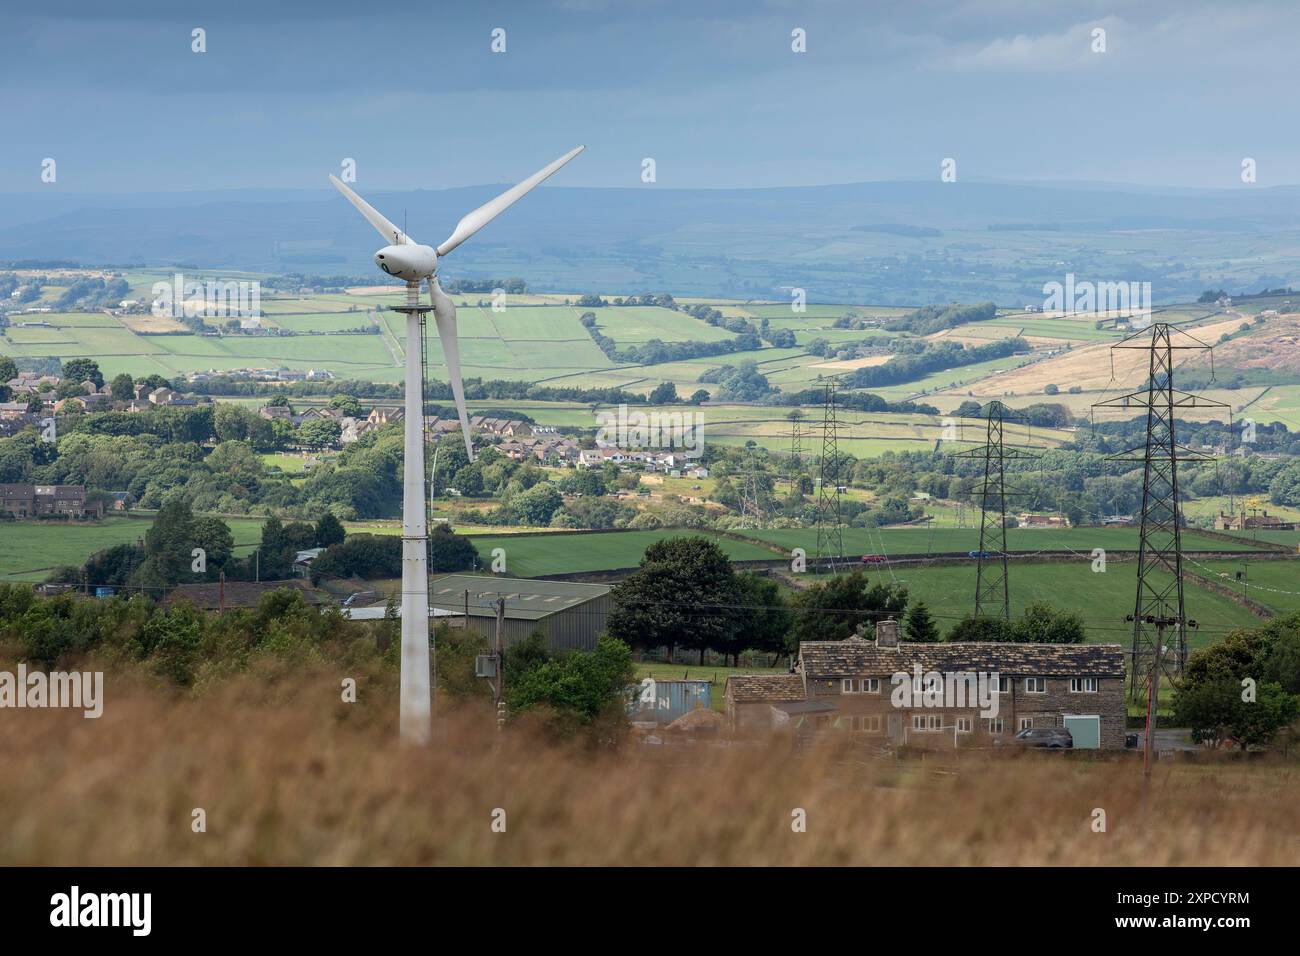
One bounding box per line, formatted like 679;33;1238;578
329;146;586;744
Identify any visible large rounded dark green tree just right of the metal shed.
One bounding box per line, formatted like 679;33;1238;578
607;536;737;659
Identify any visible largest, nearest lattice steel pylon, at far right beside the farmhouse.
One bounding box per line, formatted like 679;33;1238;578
1093;323;1231;701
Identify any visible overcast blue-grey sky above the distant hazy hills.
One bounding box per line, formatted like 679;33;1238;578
0;0;1300;193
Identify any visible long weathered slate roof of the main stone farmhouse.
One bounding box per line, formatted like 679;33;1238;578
800;637;1125;678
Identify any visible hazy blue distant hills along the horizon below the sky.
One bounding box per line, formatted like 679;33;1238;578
0;182;1300;306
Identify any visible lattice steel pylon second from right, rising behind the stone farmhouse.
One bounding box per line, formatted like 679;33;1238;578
956;402;1037;620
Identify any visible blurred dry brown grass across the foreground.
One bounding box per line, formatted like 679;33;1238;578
0;671;1300;866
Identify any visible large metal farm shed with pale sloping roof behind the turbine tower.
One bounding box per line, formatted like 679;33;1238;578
429;575;612;650
